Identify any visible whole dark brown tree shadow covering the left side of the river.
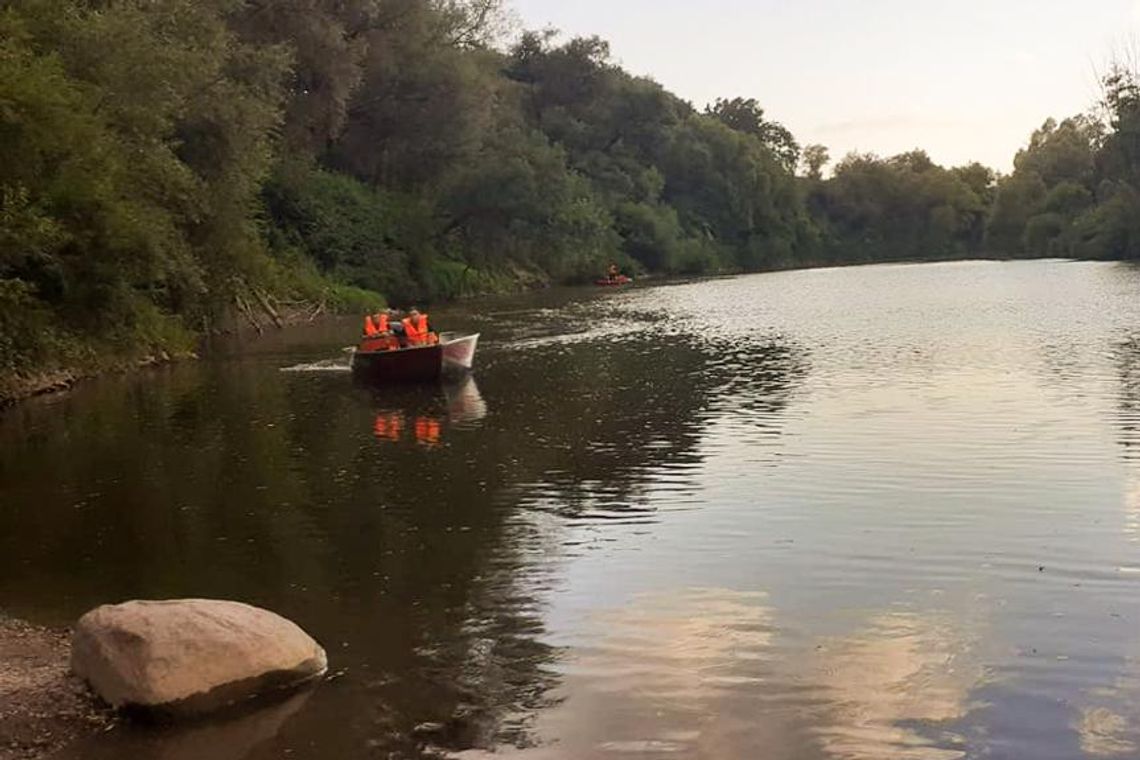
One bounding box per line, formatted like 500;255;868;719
0;288;807;760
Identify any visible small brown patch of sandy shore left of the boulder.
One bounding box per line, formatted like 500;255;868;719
0;614;113;760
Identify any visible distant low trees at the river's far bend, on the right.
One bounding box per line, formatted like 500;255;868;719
806;66;1140;262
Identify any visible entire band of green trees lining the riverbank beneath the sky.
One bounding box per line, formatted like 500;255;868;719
0;0;1140;387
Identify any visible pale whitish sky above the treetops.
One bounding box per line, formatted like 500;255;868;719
508;0;1140;171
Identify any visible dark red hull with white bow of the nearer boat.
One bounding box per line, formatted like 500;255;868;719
352;333;479;383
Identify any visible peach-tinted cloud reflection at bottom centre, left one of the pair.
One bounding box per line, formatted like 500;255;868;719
490;589;779;758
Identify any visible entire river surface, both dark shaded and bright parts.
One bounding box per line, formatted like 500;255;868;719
0;261;1140;760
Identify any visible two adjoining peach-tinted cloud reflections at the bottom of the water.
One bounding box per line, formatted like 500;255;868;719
462;589;982;760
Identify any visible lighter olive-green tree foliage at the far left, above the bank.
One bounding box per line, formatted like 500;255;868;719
0;0;286;373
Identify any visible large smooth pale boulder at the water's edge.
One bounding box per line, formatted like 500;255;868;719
71;599;328;713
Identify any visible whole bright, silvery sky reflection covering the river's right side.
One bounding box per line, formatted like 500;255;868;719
485;263;1140;759
